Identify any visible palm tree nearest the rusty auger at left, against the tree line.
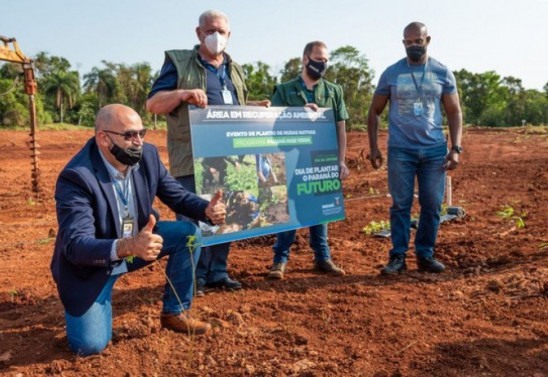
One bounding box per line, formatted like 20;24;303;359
44;71;80;123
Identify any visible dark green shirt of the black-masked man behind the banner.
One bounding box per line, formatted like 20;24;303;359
271;77;348;122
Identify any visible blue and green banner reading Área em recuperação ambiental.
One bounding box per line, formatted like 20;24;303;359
190;106;345;246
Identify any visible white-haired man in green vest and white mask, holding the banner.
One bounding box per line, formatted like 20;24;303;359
147;10;270;296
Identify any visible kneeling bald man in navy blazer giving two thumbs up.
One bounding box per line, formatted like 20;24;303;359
51;104;226;355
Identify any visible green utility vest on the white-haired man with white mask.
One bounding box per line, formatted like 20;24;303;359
165;46;247;177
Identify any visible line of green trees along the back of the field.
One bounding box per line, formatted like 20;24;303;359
0;46;548;129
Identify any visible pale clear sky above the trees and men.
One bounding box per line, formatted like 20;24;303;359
0;0;548;90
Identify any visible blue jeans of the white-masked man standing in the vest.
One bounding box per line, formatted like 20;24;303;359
176;175;230;285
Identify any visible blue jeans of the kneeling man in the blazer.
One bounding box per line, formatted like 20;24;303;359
65;221;201;356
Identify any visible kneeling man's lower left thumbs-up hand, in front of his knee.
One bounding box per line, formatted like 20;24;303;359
116;215;164;261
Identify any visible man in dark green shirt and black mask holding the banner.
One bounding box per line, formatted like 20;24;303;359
268;41;349;279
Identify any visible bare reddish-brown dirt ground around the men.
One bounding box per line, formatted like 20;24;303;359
0;128;548;377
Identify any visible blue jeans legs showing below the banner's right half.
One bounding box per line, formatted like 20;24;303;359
272;224;331;263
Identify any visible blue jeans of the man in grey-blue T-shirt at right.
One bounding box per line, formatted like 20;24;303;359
388;144;447;258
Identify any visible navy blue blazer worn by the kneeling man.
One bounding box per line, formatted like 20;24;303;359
51;138;209;316
